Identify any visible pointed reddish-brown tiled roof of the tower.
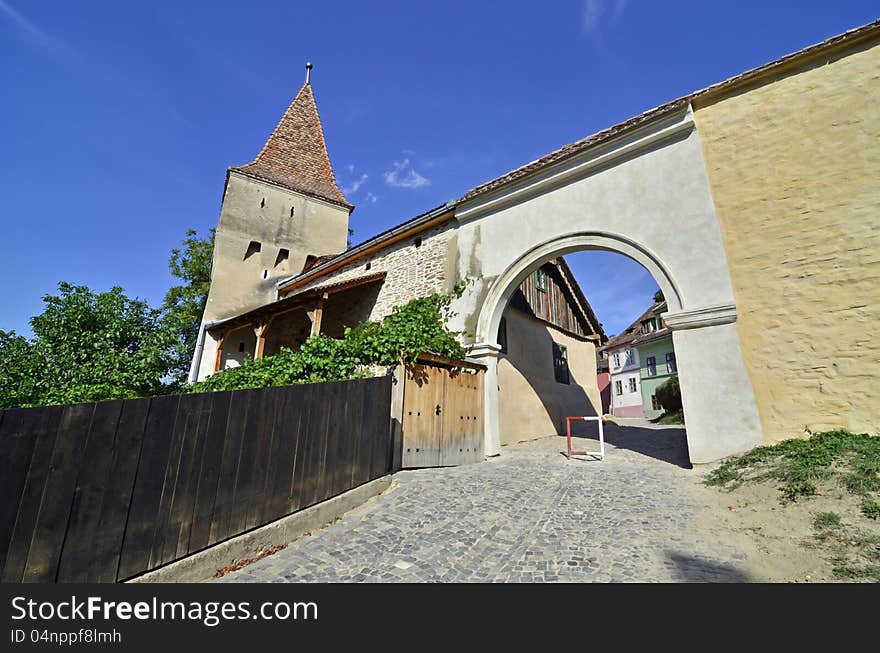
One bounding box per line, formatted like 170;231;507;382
230;82;354;211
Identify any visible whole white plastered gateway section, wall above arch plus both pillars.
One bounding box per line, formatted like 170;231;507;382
453;110;762;462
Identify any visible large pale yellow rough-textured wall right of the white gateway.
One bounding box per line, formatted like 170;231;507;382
694;39;880;442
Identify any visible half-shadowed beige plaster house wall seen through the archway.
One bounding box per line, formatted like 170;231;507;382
498;306;601;445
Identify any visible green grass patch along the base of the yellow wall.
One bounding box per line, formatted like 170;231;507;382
704;430;880;502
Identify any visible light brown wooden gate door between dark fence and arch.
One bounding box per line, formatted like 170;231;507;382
401;365;483;469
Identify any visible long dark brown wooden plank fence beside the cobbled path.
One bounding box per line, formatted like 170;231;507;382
0;377;392;583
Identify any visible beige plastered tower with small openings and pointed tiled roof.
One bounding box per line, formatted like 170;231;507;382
202;64;354;322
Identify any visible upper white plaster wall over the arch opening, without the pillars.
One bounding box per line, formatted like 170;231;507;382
457;115;733;339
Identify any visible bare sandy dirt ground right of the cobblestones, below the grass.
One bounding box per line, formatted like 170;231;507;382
699;468;880;583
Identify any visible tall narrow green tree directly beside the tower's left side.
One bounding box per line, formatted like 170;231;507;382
162;229;214;387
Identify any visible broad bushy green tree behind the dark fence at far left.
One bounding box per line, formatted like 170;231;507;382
0;282;173;407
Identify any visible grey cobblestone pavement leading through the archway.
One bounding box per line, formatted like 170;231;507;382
219;424;760;582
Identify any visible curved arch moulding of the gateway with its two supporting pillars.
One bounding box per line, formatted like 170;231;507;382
471;230;761;463
